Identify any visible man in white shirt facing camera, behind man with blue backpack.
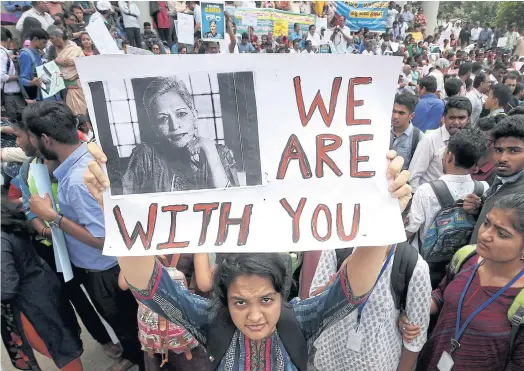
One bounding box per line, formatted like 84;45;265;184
409;97;471;191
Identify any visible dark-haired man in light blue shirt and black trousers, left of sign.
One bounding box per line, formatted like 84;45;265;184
23;102;143;370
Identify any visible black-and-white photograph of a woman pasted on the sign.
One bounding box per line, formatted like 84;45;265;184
89;72;262;196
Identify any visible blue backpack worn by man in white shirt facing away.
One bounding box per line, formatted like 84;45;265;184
419;180;484;288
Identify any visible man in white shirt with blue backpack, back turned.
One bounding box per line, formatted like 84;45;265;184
406;129;489;288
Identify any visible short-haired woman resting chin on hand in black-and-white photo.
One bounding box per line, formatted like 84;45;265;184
122;77;239;194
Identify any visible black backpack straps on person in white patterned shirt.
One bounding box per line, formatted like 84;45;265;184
336;242;418;311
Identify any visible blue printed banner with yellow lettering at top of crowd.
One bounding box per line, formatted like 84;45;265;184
336;1;388;32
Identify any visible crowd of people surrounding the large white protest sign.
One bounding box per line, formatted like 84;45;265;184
0;1;524;371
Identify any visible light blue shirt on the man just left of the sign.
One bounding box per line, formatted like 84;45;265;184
53;143;117;271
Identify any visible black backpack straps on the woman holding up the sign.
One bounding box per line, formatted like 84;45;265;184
206;304;308;371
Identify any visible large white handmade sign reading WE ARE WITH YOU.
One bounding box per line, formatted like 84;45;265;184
77;54;406;255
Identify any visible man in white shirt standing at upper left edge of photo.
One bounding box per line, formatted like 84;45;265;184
0;27;25;122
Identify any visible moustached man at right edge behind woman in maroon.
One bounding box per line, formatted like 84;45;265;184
464;115;524;244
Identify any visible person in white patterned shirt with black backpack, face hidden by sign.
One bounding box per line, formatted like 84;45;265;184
311;243;431;371
